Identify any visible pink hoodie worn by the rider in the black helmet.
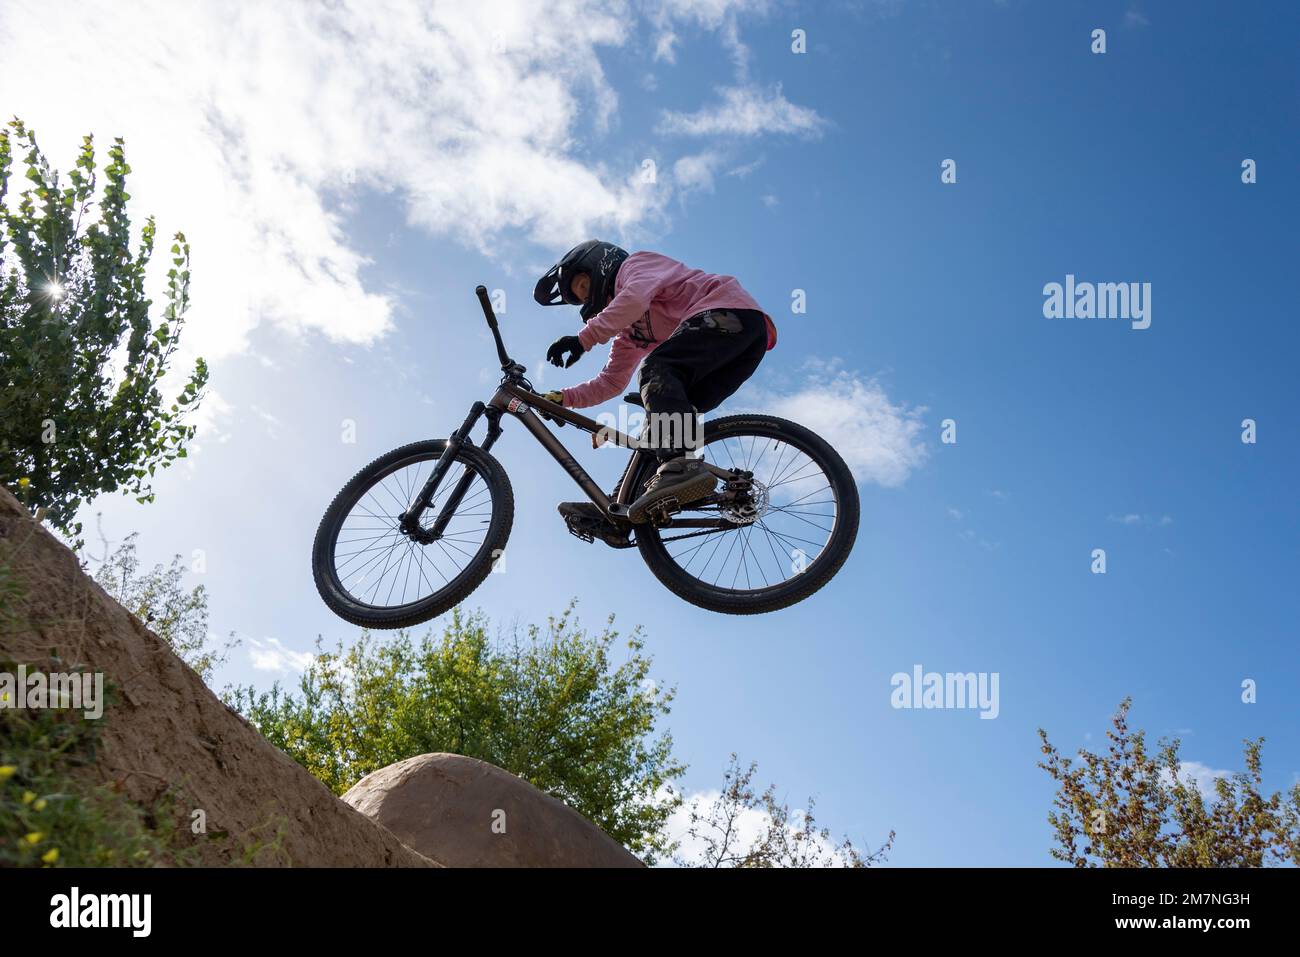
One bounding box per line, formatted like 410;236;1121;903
564;252;776;408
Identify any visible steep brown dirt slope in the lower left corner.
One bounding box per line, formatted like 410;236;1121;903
0;489;438;867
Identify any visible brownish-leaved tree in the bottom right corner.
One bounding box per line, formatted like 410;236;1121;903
1039;698;1300;867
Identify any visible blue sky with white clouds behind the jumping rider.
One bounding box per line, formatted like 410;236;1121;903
0;0;1300;866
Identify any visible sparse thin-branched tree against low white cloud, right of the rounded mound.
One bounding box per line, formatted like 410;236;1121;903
675;754;894;867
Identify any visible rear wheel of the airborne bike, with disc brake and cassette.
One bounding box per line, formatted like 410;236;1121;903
636;415;859;615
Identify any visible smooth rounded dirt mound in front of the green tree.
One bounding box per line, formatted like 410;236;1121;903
343;754;642;867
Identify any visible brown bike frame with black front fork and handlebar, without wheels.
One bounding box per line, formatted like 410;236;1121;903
398;286;742;542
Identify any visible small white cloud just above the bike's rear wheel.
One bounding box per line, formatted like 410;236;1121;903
754;363;928;488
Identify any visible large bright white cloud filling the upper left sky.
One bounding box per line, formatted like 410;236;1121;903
0;0;663;359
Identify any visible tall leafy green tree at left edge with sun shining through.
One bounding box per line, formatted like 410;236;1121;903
0;120;208;546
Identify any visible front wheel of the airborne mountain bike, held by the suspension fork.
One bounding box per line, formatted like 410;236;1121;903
312;439;515;628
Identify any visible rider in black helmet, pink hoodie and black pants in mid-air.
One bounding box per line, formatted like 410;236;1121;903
533;239;776;521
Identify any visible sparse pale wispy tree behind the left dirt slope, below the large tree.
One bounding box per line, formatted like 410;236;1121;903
95;532;238;681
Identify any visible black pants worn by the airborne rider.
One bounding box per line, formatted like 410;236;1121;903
640;309;767;462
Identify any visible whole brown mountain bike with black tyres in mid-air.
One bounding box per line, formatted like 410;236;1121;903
312;286;859;628
